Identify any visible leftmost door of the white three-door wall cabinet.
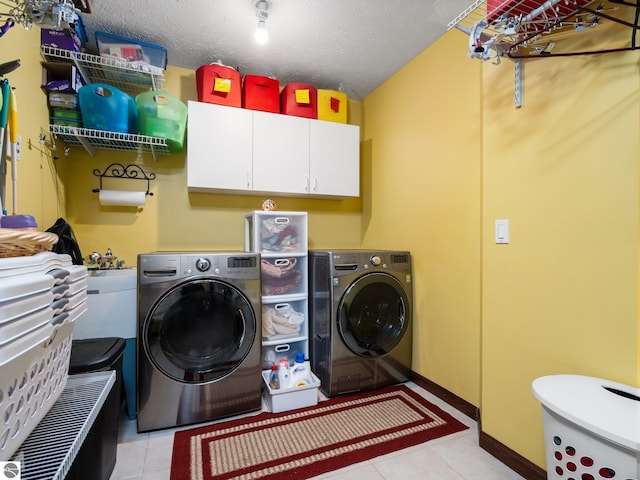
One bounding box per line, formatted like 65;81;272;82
187;102;253;191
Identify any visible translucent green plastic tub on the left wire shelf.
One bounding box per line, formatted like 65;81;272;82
136;92;187;153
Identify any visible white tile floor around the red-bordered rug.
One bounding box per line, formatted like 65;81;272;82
111;382;523;480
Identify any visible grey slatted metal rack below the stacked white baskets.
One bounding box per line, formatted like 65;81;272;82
12;371;116;480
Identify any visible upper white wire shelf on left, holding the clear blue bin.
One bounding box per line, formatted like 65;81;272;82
42;45;164;93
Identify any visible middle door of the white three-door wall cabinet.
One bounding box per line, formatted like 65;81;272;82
253;111;309;193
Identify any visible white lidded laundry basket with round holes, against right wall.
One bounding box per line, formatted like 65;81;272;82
532;375;640;480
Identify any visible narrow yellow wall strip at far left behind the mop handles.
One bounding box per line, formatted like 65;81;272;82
0;26;65;230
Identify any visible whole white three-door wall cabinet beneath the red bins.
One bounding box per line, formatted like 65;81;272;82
187;102;360;197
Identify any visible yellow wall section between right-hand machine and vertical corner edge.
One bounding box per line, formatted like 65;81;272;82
363;33;482;405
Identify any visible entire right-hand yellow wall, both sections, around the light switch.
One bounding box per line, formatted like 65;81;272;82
363;10;640;467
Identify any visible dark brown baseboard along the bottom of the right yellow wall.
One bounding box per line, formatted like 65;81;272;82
411;371;547;480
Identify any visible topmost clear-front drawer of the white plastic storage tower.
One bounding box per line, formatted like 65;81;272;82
245;211;308;255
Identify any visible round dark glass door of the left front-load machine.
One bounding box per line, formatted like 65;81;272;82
142;278;257;383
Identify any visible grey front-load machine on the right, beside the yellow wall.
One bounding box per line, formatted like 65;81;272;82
309;250;413;397
